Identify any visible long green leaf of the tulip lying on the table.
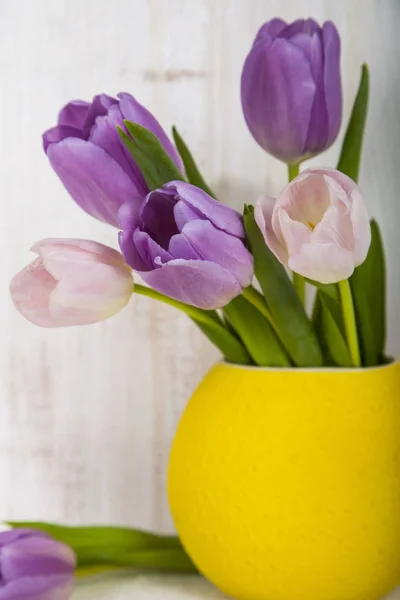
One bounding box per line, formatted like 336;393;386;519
8;522;196;575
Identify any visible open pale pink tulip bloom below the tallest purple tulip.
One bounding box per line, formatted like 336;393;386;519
255;169;371;283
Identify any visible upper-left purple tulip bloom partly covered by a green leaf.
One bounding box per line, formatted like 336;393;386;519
43;93;182;226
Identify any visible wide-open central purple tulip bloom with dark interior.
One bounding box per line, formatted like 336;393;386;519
119;181;253;309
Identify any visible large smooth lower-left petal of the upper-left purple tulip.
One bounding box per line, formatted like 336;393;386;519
47;138;140;226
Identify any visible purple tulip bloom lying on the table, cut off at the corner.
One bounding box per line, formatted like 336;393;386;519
0;529;76;600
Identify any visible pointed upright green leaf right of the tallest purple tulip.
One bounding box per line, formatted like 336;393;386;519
337;64;369;181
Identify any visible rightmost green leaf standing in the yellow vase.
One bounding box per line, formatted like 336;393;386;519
350;220;386;367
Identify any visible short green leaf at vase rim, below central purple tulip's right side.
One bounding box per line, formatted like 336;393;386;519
224;296;290;367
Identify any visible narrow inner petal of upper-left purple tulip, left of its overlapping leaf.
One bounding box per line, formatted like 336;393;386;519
89;104;149;197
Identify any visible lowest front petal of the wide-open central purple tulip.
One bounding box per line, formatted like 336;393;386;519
139;259;242;310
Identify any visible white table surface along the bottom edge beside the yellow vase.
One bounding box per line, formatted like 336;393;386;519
72;574;400;600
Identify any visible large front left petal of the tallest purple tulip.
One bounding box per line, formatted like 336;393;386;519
241;38;316;163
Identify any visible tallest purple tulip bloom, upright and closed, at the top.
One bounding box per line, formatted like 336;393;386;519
241;19;342;164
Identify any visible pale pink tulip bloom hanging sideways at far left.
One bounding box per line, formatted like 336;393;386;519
10;239;133;327
